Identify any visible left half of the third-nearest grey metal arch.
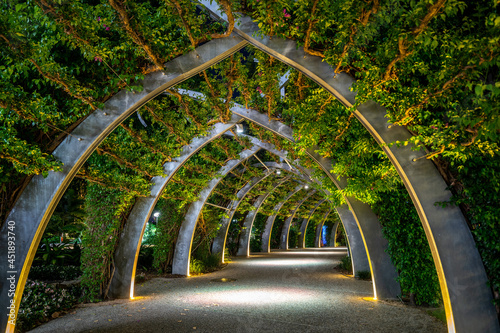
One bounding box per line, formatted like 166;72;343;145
172;147;260;276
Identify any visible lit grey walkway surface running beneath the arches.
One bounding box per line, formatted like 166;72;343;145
32;249;446;333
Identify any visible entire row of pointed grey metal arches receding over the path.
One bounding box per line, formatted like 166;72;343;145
0;1;500;332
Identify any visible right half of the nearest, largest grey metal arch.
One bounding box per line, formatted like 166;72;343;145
201;0;500;332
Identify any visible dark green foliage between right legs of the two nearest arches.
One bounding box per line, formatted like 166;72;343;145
373;186;441;305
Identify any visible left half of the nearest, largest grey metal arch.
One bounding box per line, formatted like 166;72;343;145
0;35;248;332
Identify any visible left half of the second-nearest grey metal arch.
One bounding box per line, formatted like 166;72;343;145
109;115;241;298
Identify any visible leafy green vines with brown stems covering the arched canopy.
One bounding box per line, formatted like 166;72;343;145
0;0;500;330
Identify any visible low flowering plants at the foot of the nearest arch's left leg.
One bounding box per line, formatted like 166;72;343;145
16;280;79;332
